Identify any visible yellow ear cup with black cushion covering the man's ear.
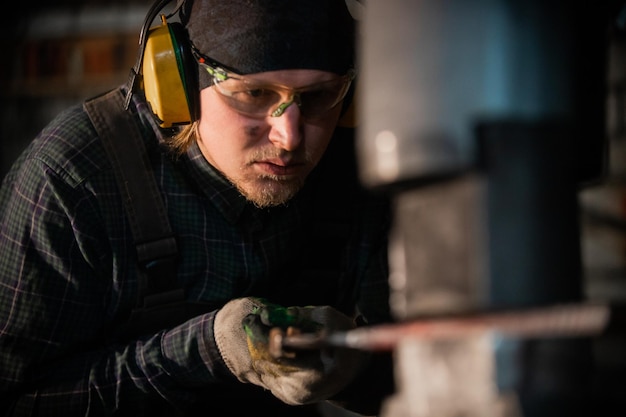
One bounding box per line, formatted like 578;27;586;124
142;22;199;127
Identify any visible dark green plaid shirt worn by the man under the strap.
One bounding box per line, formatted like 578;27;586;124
0;88;389;416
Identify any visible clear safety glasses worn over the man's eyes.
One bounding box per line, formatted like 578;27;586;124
194;48;355;119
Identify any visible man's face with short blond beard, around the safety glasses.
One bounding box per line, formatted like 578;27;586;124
199;70;341;207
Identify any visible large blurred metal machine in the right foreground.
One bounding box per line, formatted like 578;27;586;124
357;0;614;417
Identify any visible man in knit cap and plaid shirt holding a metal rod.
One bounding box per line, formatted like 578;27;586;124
0;0;390;417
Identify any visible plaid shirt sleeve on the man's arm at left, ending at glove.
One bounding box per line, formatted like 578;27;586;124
0;152;227;417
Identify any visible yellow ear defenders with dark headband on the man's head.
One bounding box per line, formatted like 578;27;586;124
125;0;200;128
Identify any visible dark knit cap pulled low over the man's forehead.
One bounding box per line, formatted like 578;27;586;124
181;0;355;86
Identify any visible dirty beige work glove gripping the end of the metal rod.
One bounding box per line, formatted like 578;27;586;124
214;298;368;405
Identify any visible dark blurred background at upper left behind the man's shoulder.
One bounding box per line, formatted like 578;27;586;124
0;0;152;176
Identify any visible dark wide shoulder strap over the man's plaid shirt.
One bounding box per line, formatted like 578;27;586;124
84;88;182;307
